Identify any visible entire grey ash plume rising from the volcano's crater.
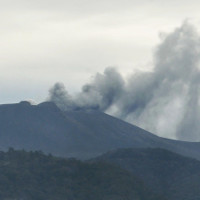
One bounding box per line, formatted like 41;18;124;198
49;22;200;141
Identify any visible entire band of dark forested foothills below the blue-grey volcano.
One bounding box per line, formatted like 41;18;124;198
0;148;200;200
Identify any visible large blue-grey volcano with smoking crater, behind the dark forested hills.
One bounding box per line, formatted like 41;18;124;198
0;101;200;159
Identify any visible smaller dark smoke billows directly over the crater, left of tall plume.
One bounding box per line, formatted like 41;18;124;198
49;68;124;111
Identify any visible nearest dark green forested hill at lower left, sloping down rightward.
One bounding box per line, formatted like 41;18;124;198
0;149;163;200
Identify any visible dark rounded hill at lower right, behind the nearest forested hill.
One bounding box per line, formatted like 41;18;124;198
94;148;200;200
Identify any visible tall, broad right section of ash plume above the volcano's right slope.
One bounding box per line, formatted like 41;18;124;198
119;22;200;140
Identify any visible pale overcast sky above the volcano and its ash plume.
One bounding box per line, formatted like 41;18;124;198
0;0;200;103
